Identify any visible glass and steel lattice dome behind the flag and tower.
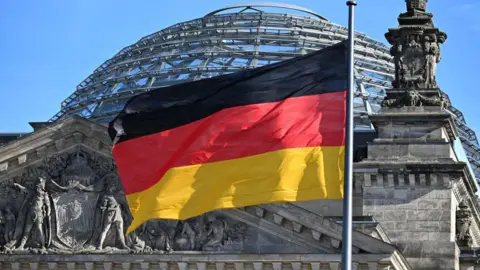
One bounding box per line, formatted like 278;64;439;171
49;3;480;181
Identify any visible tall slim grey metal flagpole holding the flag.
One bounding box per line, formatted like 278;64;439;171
342;1;357;270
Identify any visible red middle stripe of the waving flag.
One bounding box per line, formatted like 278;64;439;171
112;92;345;194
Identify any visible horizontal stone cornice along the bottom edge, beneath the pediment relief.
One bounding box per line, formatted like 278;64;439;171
0;253;411;270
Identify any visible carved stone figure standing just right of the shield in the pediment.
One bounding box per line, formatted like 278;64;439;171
97;189;128;249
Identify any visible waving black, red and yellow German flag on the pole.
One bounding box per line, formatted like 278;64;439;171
109;43;347;232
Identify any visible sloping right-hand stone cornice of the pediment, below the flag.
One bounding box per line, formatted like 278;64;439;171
220;203;404;254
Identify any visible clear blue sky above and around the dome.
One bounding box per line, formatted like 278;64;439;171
0;0;480;135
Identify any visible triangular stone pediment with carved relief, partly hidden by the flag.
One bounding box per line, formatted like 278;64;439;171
0;117;402;260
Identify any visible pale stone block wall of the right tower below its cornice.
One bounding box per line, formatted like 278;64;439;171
356;172;458;269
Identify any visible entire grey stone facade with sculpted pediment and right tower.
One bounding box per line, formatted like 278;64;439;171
0;0;480;270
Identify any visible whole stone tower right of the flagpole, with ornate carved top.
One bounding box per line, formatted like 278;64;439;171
355;0;478;269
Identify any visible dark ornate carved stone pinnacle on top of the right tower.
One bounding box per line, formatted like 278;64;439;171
382;0;447;107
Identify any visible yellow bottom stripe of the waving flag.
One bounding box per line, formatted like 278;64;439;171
127;146;344;233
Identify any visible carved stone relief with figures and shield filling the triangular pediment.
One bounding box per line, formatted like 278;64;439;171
0;151;246;253
